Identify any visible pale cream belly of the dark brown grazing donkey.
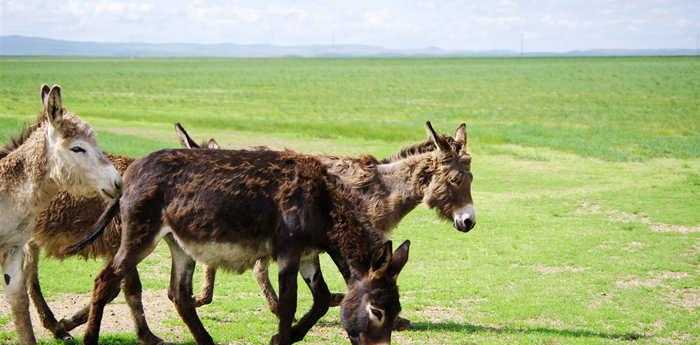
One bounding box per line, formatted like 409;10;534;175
173;234;272;274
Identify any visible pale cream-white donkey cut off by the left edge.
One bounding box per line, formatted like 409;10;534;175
0;85;122;344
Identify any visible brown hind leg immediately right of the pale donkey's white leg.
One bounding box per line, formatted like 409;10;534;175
24;242;73;341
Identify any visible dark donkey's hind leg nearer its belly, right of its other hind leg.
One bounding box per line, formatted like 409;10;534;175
165;236;214;345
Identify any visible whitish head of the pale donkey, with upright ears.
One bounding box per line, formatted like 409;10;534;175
41;85;122;199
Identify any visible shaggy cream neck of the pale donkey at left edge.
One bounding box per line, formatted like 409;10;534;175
0;126;58;211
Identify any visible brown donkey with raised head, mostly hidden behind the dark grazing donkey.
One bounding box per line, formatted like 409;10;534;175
191;122;476;330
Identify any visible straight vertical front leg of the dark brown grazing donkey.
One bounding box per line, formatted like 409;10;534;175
270;253;300;345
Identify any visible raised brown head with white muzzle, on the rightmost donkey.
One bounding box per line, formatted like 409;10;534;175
423;122;476;232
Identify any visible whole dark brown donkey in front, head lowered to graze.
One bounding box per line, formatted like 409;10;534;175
67;149;409;345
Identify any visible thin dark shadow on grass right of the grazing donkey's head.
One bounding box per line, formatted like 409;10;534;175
410;321;646;340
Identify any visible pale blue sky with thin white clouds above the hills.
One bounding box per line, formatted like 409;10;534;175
0;0;700;52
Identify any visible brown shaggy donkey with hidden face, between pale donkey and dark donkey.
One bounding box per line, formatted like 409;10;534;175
26;123;219;344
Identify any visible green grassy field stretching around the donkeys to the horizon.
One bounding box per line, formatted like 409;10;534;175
0;58;700;344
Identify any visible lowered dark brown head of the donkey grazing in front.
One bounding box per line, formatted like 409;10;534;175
341;241;411;345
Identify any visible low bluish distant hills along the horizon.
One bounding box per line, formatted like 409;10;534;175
0;36;696;57
